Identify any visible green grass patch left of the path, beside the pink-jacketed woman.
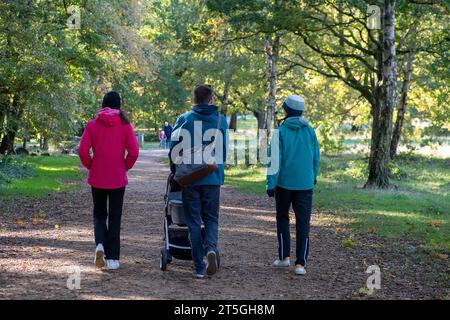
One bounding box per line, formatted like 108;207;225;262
0;156;82;198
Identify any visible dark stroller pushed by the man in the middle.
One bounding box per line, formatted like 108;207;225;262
160;173;196;271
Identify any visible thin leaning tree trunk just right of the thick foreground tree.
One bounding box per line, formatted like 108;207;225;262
390;52;414;159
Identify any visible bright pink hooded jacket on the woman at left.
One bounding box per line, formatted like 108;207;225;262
78;108;139;189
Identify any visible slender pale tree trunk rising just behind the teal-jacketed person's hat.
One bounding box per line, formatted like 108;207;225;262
265;34;280;136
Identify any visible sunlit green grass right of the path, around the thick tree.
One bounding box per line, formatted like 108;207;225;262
226;155;450;253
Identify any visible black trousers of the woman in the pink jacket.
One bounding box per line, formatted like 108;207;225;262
92;187;125;260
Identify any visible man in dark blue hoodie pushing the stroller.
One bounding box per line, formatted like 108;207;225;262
169;85;228;278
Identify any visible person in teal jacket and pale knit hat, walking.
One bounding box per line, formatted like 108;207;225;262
266;95;320;275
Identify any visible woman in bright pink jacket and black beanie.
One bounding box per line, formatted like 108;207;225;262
78;91;139;270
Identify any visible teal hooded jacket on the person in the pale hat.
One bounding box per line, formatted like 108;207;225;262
266;117;320;190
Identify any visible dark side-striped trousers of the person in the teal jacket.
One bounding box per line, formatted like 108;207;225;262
275;187;313;266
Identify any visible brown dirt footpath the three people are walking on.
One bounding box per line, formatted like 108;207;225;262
0;150;448;299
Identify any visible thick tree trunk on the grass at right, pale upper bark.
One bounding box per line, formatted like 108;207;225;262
365;0;397;189
